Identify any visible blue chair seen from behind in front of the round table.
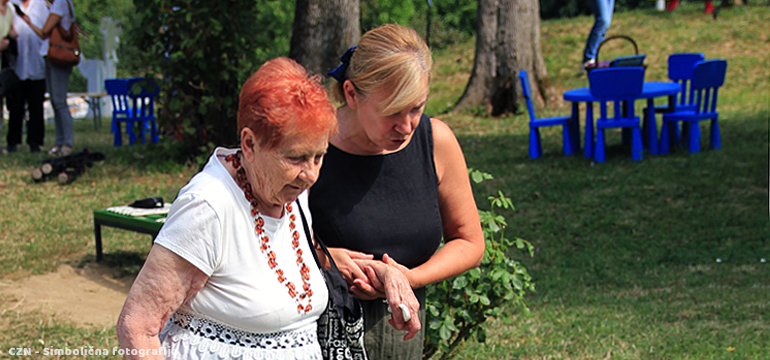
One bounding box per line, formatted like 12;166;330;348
588;67;644;163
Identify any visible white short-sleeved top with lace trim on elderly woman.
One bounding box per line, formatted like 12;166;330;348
155;148;328;359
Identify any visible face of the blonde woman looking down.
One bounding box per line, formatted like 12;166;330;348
358;93;428;151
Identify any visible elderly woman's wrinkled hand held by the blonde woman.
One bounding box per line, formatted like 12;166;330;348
356;260;422;341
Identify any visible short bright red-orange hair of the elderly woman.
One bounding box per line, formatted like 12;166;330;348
238;58;337;150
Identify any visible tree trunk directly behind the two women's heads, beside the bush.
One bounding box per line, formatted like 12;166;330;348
289;0;361;75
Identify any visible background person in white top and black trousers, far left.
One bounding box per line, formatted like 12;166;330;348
4;0;48;153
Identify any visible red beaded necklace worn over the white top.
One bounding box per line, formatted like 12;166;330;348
225;150;313;314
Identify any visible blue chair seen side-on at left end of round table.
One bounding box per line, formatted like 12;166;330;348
519;70;577;159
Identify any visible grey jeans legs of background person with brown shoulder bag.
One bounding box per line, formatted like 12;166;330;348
45;61;73;148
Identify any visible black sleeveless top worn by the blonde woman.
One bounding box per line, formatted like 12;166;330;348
310;114;443;268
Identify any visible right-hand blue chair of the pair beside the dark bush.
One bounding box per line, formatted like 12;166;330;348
126;78;160;145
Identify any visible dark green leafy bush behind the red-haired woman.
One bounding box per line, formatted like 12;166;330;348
124;0;293;159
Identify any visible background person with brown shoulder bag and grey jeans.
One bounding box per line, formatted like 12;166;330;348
24;0;75;156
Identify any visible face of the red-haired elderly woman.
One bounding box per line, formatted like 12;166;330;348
252;131;329;210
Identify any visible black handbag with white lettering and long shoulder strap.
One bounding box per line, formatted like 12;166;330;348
297;201;367;360
